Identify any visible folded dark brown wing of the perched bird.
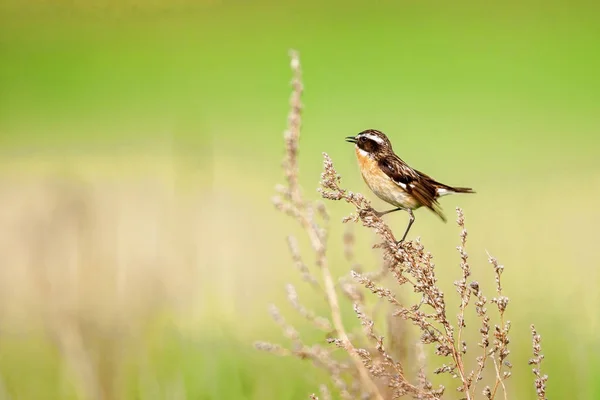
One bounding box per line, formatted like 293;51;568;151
379;155;446;222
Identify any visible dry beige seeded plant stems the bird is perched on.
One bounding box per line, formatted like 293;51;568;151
256;51;547;400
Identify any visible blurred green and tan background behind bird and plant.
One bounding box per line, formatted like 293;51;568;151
0;0;600;399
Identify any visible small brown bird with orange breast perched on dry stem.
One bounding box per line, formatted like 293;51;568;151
346;129;475;242
